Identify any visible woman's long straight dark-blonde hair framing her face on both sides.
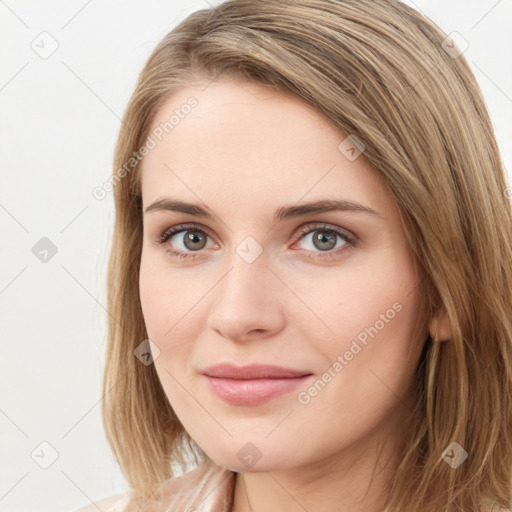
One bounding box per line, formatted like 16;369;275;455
102;0;512;512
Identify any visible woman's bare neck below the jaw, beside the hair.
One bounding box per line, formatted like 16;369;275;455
232;408;408;512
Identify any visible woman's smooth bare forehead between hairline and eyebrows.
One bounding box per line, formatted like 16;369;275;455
142;80;392;216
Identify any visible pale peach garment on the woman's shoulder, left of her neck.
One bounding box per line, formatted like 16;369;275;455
73;461;236;512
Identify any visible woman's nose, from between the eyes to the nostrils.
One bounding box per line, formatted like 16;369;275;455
207;254;286;342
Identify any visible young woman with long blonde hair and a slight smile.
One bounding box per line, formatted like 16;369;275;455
76;0;512;512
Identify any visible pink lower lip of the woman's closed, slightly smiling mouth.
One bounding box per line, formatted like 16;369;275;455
205;375;312;405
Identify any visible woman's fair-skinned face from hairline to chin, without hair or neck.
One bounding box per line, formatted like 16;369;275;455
140;80;427;472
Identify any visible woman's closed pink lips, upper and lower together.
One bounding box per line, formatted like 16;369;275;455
203;363;313;405
